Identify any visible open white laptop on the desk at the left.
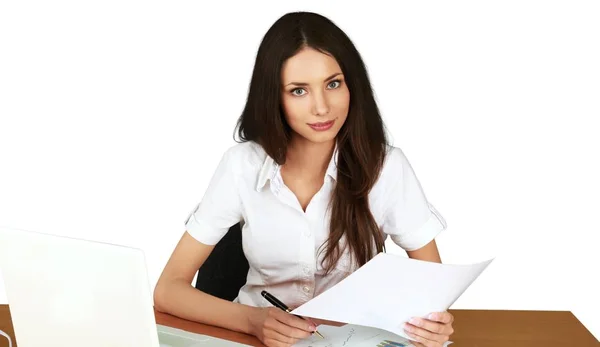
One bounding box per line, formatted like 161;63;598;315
0;228;247;347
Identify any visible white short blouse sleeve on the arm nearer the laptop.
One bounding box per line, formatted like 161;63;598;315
185;149;242;245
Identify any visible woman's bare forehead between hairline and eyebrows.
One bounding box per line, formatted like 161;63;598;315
281;47;342;84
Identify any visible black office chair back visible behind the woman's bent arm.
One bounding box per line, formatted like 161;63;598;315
195;223;249;301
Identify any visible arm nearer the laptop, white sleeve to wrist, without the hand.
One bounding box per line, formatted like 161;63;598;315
154;150;256;333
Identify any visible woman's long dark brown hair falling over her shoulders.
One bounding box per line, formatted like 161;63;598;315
236;12;387;272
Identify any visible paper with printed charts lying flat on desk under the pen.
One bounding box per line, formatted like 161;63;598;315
294;324;451;347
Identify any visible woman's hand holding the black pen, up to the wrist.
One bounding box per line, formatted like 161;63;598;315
250;307;317;347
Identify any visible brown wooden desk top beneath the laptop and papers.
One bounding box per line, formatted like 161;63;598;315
0;305;600;347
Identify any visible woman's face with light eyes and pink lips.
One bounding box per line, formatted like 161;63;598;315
281;48;350;143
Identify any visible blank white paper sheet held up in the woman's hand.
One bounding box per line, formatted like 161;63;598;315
293;253;493;338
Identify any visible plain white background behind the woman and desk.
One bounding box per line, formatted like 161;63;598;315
0;0;600;337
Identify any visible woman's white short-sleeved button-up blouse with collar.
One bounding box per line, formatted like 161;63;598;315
185;142;446;308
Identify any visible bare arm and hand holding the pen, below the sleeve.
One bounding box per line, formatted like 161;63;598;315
154;232;316;346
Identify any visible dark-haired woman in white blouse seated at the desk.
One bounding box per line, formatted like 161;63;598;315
154;12;453;346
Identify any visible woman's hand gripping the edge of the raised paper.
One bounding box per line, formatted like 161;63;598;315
404;312;454;347
